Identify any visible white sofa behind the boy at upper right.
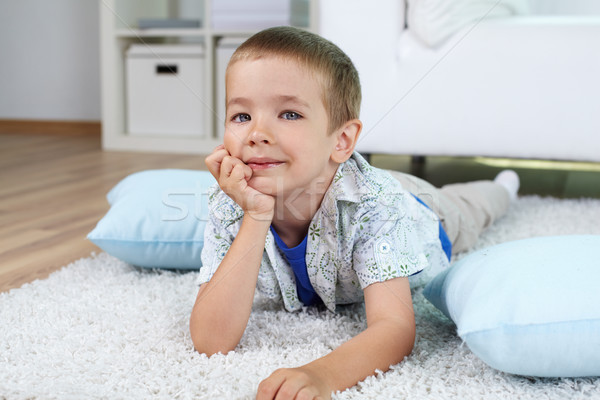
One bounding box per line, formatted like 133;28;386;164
318;0;600;161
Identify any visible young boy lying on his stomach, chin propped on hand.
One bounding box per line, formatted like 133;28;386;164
190;27;518;399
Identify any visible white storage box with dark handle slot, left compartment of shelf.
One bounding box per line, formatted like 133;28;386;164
126;44;207;137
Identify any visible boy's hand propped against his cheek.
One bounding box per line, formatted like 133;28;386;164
205;145;275;221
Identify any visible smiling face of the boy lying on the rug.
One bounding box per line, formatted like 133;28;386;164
224;57;337;196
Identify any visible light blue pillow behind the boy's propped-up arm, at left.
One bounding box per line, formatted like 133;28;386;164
88;169;215;269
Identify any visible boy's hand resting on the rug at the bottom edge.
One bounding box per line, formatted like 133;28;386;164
256;366;331;400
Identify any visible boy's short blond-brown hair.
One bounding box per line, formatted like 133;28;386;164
229;26;361;132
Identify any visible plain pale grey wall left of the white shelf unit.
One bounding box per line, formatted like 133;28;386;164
0;0;100;121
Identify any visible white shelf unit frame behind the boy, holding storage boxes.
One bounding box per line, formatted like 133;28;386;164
99;0;319;154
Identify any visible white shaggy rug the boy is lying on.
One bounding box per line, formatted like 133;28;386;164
0;197;600;400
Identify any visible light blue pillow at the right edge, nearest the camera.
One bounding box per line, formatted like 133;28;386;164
424;235;600;377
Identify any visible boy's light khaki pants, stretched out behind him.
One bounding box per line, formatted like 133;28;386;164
388;171;510;254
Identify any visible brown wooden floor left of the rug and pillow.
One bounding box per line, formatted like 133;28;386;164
0;123;205;292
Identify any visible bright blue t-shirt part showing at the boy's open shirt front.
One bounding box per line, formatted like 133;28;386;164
271;227;321;306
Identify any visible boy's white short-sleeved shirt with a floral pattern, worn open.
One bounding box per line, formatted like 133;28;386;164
198;153;449;311
